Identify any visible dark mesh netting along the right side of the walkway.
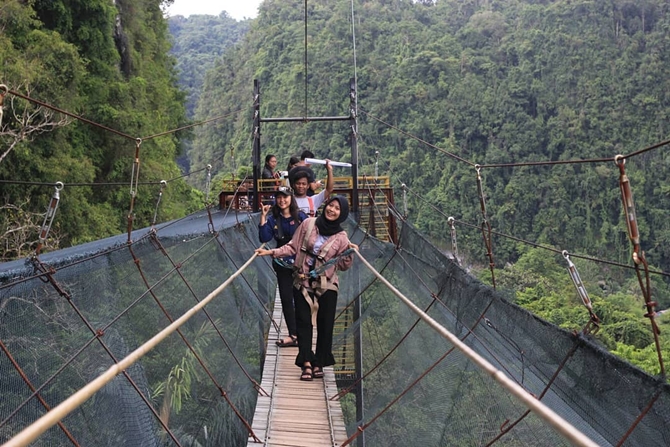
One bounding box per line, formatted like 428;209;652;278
337;220;670;446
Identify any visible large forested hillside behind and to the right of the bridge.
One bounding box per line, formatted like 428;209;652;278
190;0;670;372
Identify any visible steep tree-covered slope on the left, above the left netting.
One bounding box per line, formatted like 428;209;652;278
0;0;202;259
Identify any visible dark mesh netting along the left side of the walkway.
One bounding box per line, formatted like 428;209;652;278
0;211;275;447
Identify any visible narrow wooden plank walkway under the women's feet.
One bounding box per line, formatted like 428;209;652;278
247;292;347;447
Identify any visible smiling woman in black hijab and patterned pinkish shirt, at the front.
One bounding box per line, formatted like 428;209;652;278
256;196;358;380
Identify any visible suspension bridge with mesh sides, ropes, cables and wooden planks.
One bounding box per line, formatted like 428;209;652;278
0;0;670;440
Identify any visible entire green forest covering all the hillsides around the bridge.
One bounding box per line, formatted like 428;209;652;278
0;0;670;382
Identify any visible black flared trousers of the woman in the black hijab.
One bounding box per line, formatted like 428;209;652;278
293;288;337;367
